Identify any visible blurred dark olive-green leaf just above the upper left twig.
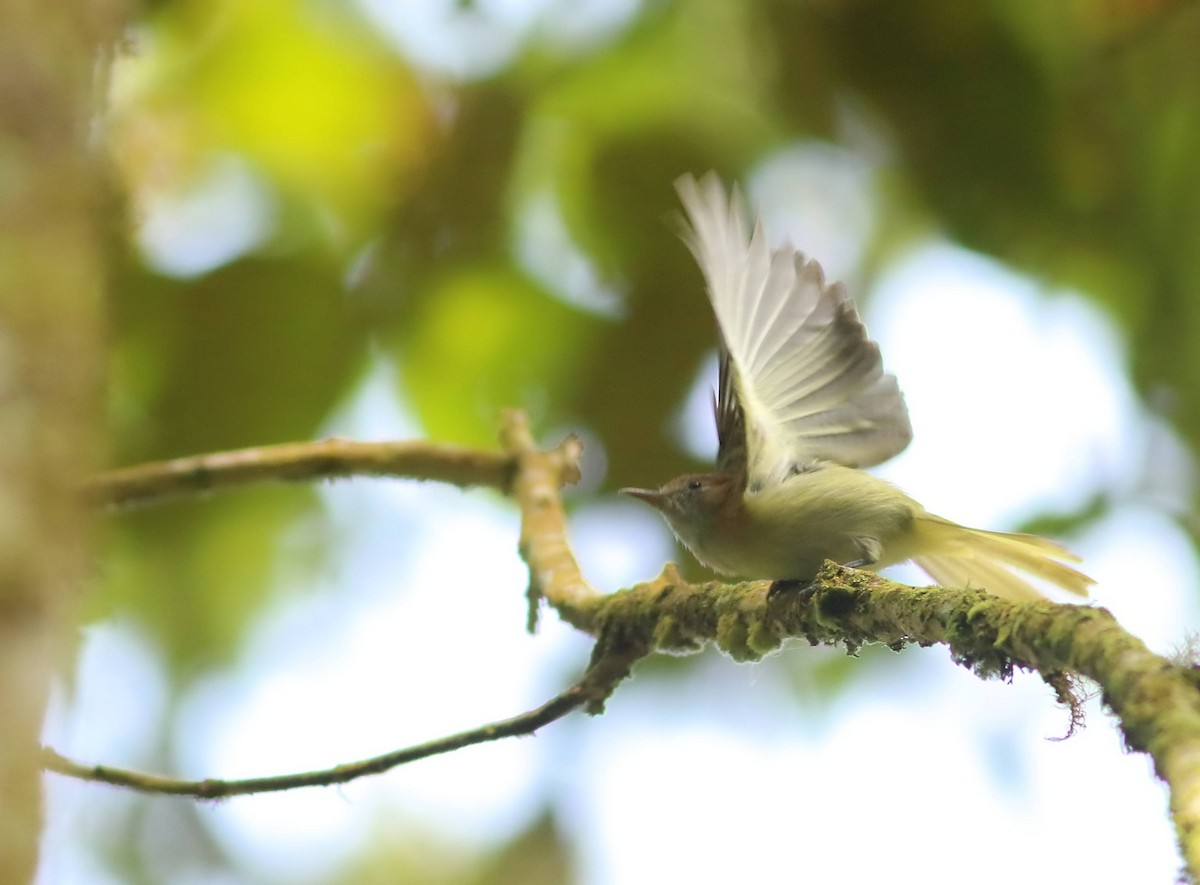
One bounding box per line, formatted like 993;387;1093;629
113;257;366;463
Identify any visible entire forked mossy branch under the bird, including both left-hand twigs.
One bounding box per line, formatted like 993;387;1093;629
46;413;1200;880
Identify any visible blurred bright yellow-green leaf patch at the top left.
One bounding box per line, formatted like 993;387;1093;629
114;0;433;239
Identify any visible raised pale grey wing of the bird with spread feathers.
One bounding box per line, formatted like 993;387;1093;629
676;173;912;482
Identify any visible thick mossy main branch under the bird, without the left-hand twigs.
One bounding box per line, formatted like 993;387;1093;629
492;414;1200;881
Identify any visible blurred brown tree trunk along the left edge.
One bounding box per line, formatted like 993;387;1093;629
0;0;120;883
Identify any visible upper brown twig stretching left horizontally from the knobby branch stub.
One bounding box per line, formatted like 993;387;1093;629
83;439;516;506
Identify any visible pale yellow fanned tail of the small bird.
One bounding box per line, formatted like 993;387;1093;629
913;513;1096;602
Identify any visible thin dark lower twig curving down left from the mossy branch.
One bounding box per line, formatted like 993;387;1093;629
42;643;644;799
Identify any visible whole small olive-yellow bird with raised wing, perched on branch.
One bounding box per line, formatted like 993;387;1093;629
622;173;1094;601
